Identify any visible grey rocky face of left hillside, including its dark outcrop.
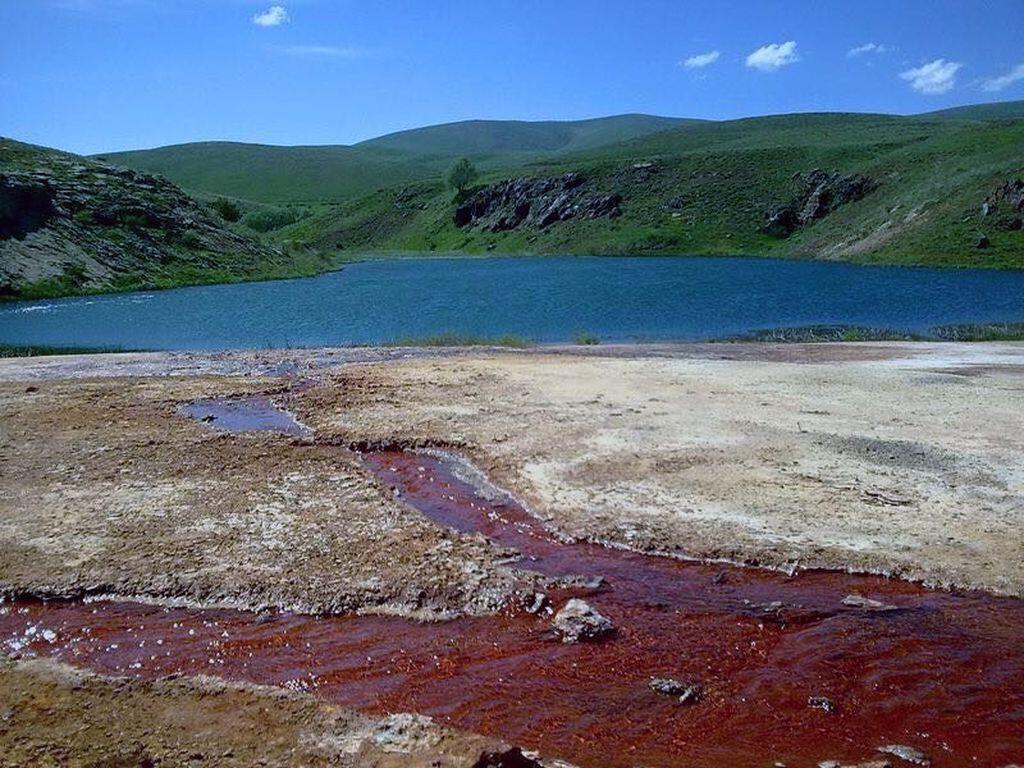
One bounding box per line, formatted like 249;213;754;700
0;140;283;294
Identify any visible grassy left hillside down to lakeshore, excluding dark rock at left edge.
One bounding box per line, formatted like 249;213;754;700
0;139;341;299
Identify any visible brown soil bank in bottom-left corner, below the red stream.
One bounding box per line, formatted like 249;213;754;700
0;659;524;768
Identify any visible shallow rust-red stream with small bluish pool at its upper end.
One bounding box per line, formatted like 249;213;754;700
0;397;1024;768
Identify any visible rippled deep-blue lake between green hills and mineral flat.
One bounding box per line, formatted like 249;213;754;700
0;257;1024;349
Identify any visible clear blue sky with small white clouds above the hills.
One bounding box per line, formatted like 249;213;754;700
0;0;1024;153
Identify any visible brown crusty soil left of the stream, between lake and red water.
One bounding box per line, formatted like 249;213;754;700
0;378;513;616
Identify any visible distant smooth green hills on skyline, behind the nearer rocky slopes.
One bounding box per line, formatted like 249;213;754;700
100;115;692;203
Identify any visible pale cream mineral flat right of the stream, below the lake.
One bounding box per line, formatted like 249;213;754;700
292;344;1024;596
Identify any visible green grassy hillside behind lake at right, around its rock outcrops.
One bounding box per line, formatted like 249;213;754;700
282;114;1024;267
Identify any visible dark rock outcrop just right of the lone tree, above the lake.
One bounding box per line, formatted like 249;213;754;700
455;173;623;232
